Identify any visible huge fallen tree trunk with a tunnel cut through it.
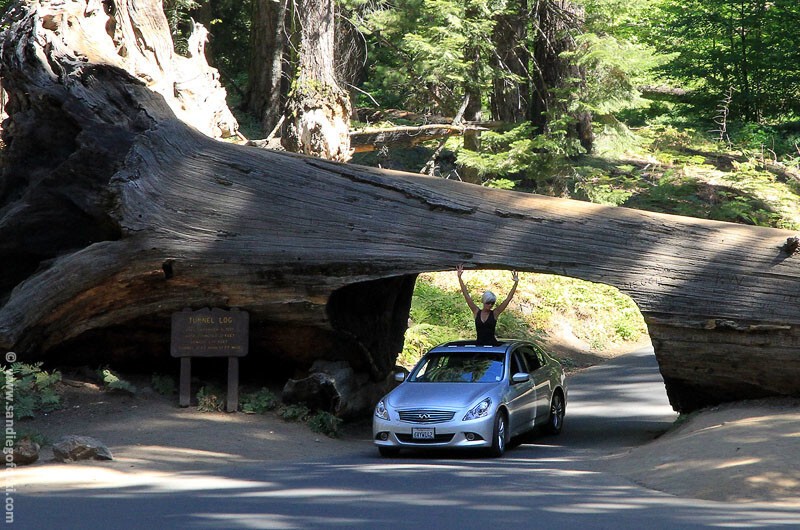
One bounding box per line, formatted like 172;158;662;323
0;0;800;411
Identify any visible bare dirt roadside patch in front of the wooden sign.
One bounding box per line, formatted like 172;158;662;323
9;379;371;492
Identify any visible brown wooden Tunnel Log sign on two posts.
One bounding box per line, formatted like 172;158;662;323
170;308;245;412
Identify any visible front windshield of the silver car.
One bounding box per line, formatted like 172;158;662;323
409;352;504;383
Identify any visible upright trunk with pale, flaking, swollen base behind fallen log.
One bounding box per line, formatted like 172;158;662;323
281;0;351;162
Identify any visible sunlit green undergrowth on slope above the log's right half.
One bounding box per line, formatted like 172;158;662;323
571;125;800;229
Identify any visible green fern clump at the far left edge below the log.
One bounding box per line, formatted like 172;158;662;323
0;362;61;420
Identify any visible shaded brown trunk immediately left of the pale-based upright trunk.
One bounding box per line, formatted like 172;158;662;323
246;0;288;134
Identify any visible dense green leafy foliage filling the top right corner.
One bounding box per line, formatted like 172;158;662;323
640;0;800;121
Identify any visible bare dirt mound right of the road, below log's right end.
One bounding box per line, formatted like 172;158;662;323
599;399;800;506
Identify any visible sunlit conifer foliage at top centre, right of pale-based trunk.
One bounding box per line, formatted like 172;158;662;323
354;0;496;116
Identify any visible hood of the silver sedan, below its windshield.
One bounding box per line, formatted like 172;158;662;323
386;383;498;409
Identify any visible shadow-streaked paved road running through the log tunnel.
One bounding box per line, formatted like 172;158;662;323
14;351;800;530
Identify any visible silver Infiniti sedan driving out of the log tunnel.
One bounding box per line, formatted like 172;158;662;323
372;341;567;456
